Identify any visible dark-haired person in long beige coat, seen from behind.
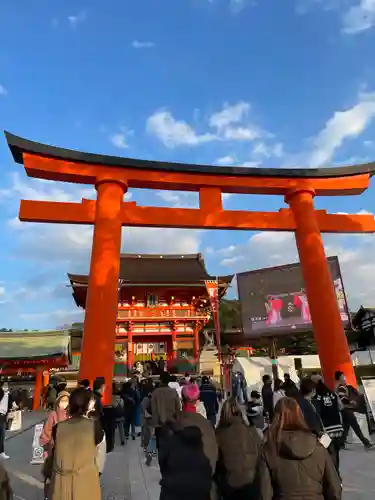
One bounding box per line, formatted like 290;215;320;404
50;388;104;500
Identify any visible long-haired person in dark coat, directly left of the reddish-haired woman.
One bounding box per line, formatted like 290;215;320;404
216;397;262;500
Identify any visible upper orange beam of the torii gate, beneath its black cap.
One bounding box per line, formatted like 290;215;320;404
23;152;370;196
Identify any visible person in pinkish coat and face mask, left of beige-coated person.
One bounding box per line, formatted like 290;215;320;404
39;391;70;499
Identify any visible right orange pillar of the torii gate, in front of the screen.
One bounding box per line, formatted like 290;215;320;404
286;190;357;388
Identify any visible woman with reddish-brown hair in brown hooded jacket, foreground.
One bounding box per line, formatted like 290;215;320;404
262;397;342;500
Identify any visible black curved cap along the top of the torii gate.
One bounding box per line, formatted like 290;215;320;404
5;132;375;179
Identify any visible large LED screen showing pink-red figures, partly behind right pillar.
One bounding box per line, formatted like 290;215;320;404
237;257;350;337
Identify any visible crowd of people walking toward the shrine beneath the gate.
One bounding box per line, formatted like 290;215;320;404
0;371;372;500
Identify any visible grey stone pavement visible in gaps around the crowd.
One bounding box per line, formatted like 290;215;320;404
5;429;375;500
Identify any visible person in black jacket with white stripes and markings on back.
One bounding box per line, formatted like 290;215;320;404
311;375;344;474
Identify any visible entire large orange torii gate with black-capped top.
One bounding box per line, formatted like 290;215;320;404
6;133;375;403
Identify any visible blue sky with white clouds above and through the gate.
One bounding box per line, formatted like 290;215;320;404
0;0;375;328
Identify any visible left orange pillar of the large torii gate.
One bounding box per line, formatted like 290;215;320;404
80;179;127;405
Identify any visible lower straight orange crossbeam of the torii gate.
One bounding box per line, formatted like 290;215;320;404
19;200;375;233
